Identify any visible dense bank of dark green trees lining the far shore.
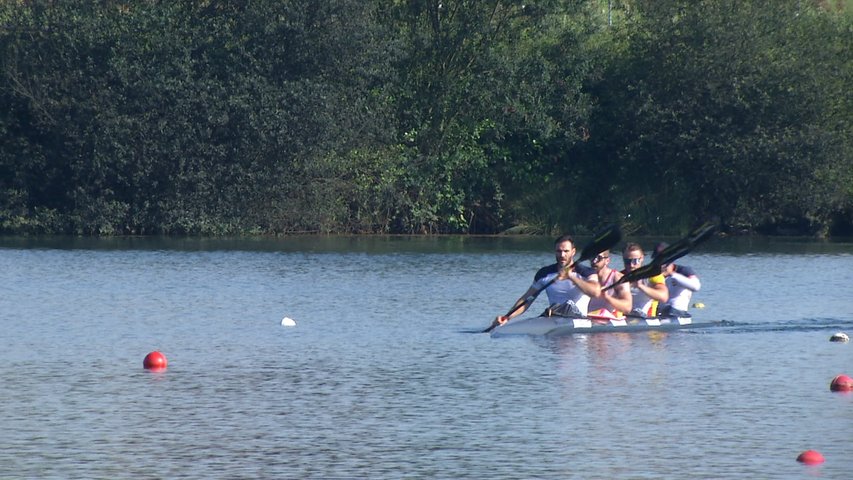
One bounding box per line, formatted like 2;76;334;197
0;0;853;235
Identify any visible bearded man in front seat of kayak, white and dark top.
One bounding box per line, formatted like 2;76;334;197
495;235;601;325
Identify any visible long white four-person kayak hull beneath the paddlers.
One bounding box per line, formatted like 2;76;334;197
492;316;724;337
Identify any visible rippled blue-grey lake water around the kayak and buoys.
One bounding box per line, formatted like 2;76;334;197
0;237;853;479
